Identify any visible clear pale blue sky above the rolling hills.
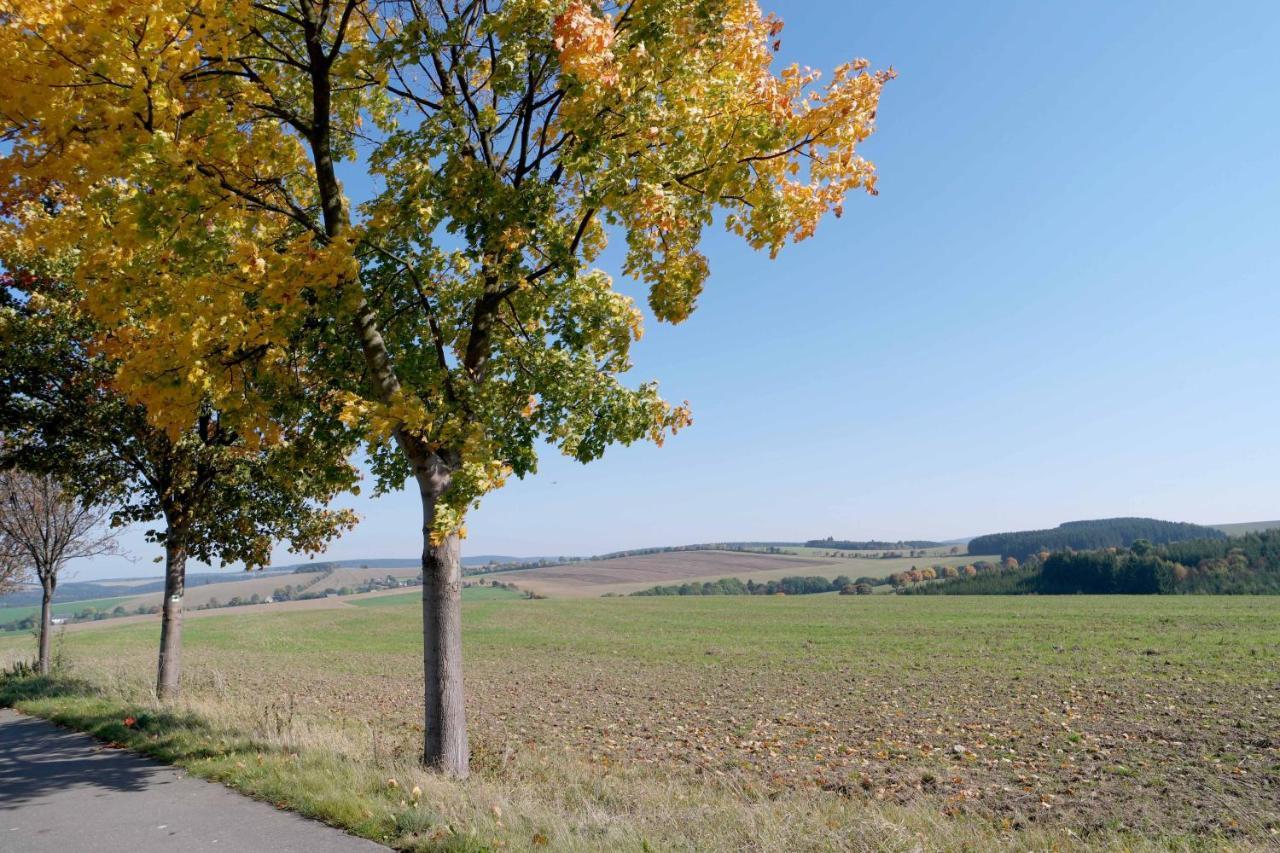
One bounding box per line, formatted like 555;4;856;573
76;0;1280;578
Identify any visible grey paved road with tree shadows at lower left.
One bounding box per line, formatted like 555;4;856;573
0;710;387;853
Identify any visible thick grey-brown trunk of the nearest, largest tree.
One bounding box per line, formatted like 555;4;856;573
422;492;470;779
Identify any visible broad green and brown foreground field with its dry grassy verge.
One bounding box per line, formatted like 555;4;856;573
0;588;1280;850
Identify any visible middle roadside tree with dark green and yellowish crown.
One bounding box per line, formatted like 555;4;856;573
0;268;356;698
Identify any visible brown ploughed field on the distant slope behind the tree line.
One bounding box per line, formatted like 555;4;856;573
492;551;977;598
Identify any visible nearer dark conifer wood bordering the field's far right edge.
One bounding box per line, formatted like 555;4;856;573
902;530;1280;596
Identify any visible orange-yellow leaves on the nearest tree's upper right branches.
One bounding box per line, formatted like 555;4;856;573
553;0;893;323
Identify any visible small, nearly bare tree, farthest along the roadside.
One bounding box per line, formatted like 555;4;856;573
0;469;115;675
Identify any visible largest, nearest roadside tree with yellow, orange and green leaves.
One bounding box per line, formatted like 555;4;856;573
0;0;892;776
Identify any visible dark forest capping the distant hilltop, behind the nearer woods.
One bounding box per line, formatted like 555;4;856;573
969;519;1228;561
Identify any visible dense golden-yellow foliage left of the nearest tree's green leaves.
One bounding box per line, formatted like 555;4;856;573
0;0;367;434
